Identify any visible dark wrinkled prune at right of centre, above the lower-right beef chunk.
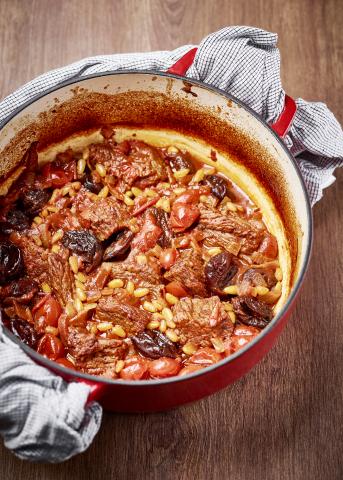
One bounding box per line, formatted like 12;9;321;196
205;252;237;293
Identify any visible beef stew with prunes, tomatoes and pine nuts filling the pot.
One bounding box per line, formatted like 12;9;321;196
0;127;282;380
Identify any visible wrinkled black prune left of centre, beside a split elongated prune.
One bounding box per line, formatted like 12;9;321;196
62;230;103;272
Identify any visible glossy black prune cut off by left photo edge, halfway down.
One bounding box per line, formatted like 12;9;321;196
0;241;24;285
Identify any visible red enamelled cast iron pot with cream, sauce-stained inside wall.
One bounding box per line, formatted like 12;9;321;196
0;51;312;412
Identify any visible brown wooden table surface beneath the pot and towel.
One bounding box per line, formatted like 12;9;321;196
0;0;343;480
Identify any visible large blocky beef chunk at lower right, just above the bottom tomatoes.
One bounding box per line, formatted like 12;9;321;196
173;297;233;347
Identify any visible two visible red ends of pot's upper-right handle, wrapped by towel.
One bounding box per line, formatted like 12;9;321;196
167;48;297;138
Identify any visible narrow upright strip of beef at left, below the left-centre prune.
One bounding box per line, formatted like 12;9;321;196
48;249;75;305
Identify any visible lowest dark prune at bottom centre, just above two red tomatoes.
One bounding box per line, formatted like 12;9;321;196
131;330;177;358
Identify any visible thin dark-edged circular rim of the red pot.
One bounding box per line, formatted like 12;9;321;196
0;70;313;387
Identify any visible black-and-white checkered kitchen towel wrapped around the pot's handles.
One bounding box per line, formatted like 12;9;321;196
0;27;343;462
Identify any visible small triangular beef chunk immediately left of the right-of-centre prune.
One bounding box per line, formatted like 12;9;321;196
164;250;207;297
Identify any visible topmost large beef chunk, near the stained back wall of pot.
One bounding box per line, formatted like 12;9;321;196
89;140;167;192
